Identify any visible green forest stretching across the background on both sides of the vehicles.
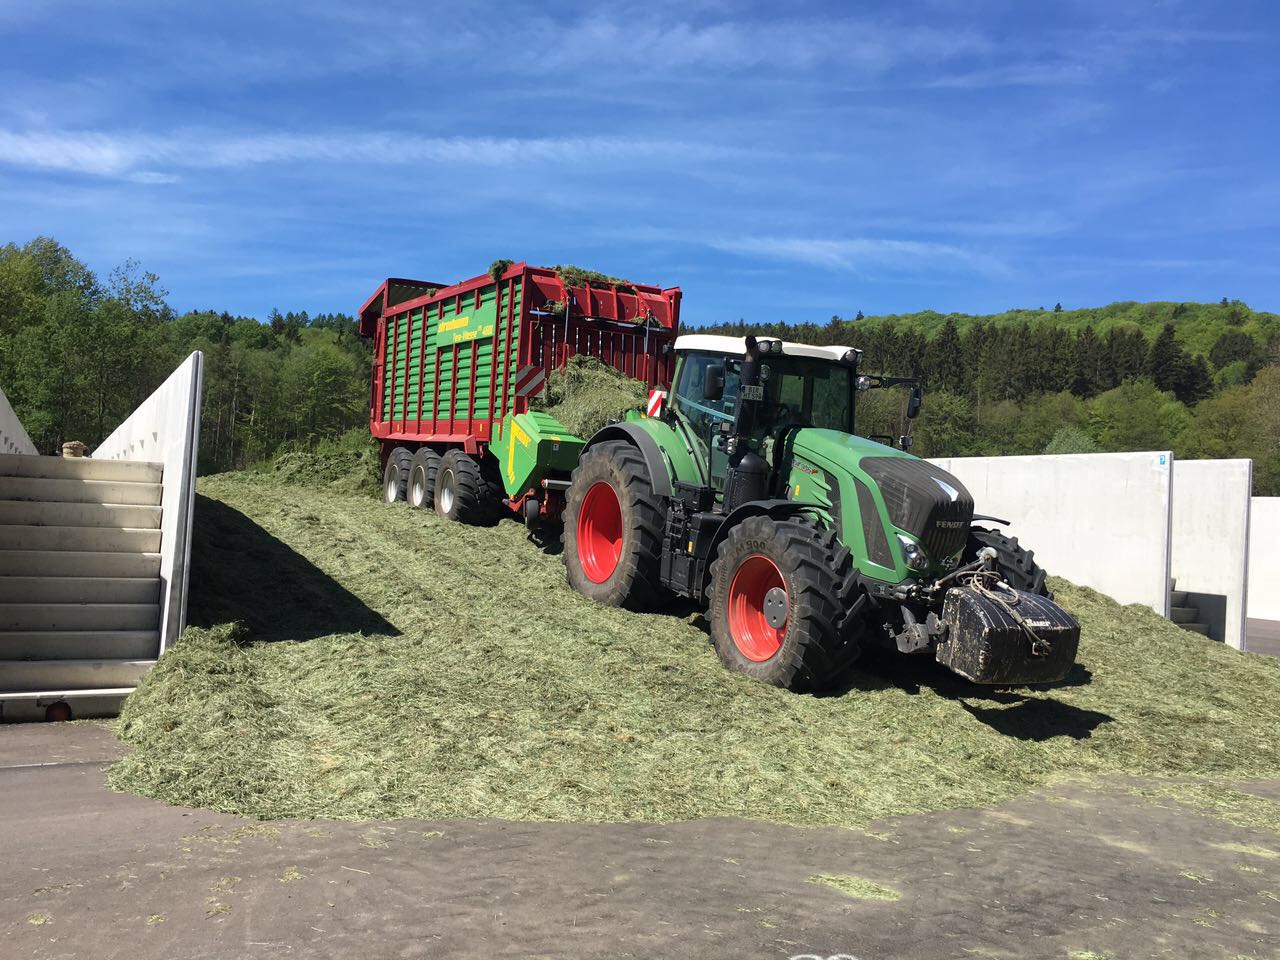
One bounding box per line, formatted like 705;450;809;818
0;238;1280;495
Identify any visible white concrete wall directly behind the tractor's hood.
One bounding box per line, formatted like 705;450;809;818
933;451;1174;616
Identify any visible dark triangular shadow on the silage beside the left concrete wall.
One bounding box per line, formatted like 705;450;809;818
187;495;399;641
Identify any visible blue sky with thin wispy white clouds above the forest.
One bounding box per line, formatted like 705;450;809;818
0;0;1280;324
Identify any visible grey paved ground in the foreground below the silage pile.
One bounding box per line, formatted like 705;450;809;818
0;724;1280;960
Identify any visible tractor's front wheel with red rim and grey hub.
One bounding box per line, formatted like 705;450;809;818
709;516;860;692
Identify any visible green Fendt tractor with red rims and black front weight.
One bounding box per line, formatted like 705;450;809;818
564;335;1079;690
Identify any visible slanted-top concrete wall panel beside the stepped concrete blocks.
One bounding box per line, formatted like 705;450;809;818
93;351;205;652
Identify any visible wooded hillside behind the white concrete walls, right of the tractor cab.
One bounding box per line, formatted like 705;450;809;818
705;298;1280;497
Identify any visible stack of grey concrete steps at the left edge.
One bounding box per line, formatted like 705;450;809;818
0;454;163;718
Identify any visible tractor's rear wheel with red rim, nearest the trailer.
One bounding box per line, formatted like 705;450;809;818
564;440;666;609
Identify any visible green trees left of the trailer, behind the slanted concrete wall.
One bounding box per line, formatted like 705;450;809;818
0;237;371;474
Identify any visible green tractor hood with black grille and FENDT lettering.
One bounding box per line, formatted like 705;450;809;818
792;428;974;582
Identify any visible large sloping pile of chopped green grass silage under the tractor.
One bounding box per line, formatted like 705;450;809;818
109;475;1280;826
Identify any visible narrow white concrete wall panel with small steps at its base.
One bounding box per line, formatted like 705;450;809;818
1170;460;1253;650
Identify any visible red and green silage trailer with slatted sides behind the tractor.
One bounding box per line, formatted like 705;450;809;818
358;262;681;522
